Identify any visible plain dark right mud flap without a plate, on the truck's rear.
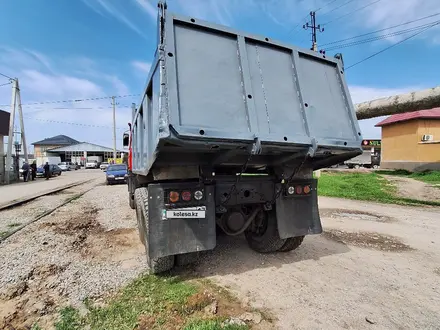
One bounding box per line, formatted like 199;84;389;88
276;180;322;239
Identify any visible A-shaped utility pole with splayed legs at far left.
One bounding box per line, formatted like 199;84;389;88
5;78;29;184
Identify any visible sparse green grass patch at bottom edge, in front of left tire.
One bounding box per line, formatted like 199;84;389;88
55;275;253;330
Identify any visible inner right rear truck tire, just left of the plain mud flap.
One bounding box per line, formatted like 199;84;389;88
245;210;286;253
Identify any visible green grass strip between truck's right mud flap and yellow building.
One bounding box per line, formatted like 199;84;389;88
318;173;440;206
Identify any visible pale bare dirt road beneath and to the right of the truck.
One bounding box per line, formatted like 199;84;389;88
197;198;440;330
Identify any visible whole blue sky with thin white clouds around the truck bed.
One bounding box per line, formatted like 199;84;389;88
0;0;440;151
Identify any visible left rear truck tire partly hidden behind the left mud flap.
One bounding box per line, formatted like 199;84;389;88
134;187;174;274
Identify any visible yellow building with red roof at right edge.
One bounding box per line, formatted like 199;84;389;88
376;108;440;171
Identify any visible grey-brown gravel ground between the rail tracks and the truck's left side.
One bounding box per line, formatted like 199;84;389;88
0;182;145;328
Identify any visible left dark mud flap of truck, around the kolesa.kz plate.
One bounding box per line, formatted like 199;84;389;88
147;183;216;258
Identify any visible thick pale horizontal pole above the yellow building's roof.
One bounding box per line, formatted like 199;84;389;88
355;86;440;119
